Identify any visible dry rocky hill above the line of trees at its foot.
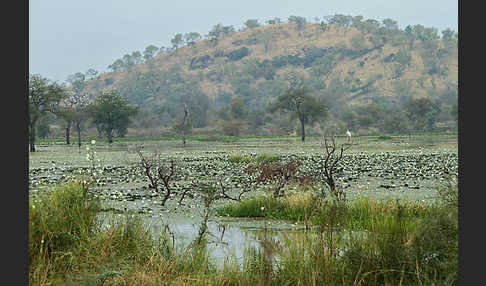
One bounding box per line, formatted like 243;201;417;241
81;15;458;135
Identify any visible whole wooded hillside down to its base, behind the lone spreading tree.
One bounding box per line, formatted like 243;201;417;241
79;15;458;135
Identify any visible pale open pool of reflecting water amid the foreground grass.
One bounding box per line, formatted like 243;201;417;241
102;213;308;267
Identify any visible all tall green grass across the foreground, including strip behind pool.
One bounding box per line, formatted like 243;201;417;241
29;182;458;285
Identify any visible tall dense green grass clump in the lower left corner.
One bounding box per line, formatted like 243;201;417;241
29;182;99;284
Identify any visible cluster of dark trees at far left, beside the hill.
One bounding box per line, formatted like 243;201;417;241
28;72;139;152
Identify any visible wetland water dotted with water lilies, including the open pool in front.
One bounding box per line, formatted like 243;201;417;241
29;136;458;264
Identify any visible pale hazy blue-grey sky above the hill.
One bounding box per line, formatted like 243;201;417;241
29;0;458;82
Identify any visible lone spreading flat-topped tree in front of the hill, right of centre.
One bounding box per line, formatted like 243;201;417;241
270;86;327;142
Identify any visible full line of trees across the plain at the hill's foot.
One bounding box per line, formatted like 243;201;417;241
29;69;457;152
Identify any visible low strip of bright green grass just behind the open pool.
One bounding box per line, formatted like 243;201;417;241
217;191;434;230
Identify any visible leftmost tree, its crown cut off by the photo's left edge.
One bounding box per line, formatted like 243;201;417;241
28;74;65;152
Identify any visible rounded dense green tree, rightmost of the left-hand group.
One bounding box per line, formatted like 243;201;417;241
87;90;138;143
